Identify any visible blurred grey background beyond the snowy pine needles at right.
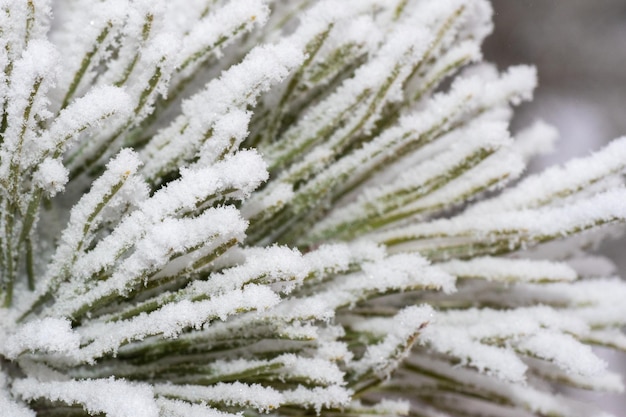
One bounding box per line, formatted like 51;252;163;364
483;0;626;416
